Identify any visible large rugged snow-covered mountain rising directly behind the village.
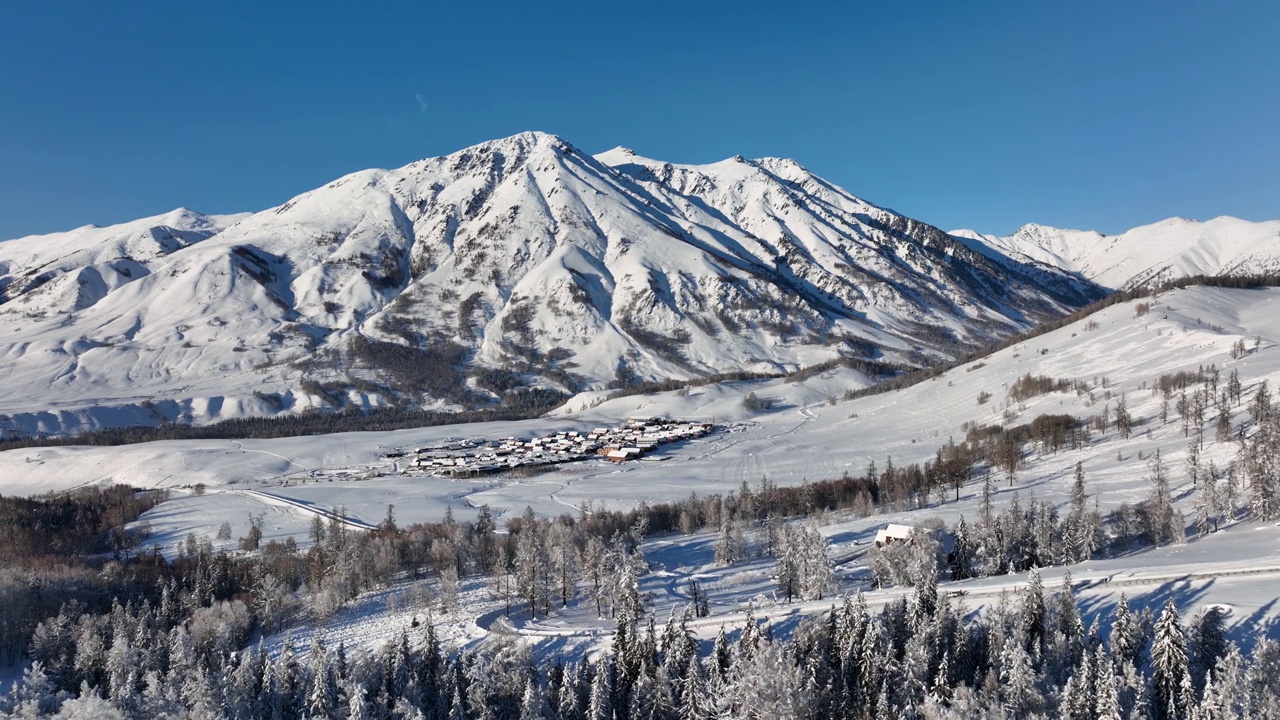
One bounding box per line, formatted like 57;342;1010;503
0;133;1102;433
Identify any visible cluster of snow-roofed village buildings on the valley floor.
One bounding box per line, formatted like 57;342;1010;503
411;418;716;478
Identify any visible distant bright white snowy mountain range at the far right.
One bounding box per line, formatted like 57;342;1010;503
951;217;1280;290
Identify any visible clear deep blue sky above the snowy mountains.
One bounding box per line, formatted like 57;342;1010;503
0;0;1280;238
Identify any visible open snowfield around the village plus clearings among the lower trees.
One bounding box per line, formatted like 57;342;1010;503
0;287;1280;652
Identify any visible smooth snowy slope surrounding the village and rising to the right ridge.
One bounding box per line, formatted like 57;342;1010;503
0;281;1280;527
